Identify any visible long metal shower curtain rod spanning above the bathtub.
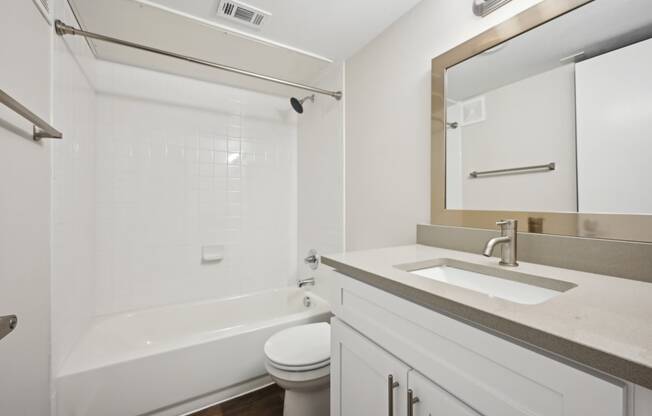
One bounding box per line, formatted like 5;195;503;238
54;20;342;100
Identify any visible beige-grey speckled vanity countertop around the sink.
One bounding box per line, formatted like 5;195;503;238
322;244;652;389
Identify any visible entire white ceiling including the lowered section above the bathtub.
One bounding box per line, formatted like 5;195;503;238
65;0;420;96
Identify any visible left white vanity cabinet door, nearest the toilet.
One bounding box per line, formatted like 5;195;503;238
331;318;408;416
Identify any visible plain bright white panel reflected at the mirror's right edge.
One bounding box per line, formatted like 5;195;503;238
577;36;652;214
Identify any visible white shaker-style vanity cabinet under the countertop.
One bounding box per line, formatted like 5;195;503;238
330;271;628;416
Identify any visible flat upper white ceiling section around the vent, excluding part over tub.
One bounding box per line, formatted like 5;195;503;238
139;0;420;61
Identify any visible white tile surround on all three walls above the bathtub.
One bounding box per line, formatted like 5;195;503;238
52;5;343;380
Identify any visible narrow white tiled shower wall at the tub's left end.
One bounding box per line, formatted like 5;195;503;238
52;0;95;374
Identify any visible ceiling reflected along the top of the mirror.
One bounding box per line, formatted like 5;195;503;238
446;0;652;100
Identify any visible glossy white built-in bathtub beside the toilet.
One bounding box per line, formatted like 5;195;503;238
55;288;330;416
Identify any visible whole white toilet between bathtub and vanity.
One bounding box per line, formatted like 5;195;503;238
265;322;331;416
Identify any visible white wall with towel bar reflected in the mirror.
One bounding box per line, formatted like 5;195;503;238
454;64;577;212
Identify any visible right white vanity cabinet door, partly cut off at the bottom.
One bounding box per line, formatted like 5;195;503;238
406;370;481;416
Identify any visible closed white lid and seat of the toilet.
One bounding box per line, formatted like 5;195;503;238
265;322;331;368
